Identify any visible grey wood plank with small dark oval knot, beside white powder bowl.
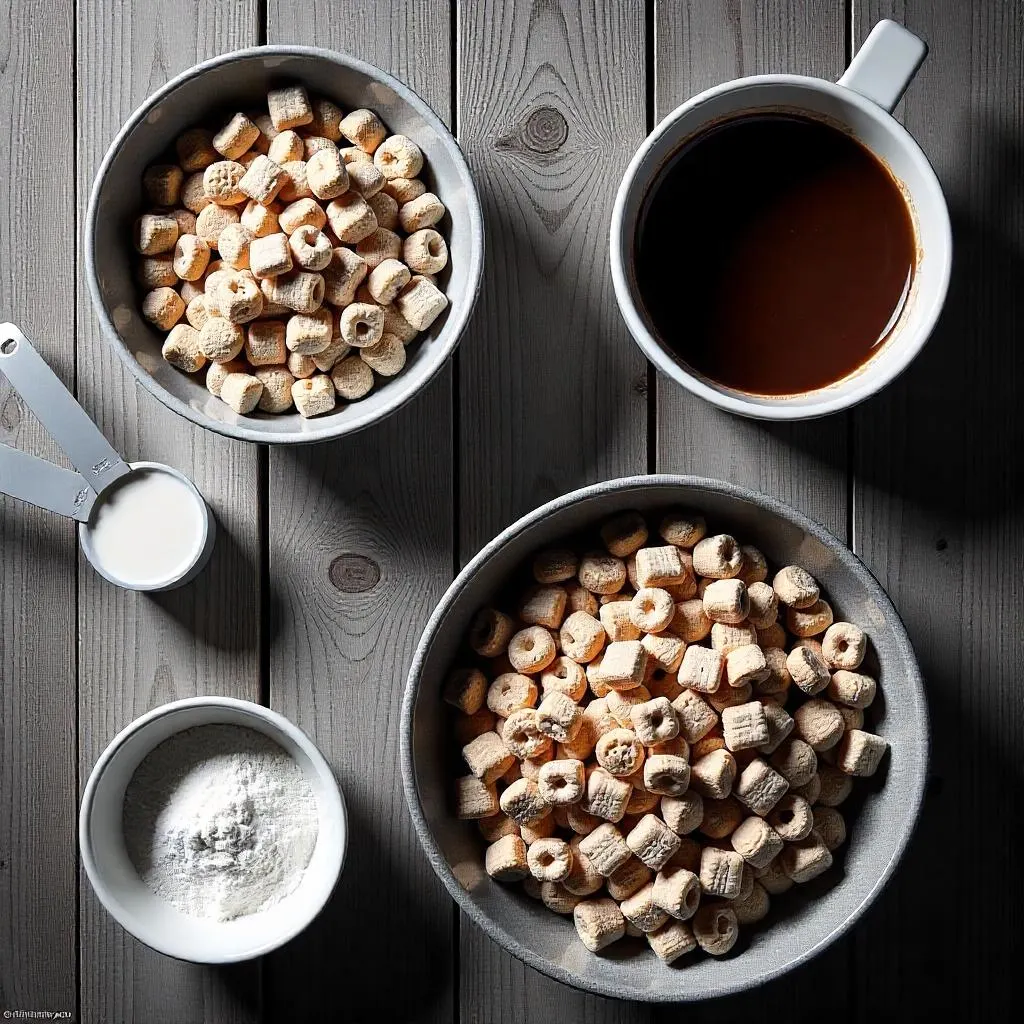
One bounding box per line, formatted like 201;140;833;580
266;0;454;1022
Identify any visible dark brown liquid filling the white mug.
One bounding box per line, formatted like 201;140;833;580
636;114;916;395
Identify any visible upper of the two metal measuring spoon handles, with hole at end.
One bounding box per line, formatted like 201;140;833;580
0;324;130;491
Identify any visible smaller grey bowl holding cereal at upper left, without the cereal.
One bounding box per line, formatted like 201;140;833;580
85;46;483;444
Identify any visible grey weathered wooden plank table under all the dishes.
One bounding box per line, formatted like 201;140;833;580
0;0;1024;1024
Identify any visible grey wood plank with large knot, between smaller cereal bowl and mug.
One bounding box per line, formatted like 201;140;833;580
457;0;649;1024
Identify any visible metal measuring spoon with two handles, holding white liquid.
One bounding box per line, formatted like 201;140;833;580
0;324;216;591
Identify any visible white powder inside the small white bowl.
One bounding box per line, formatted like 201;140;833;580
123;725;317;921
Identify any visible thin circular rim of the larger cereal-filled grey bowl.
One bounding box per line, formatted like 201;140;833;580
399;473;931;1004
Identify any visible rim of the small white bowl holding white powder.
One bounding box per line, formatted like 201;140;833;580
78;695;348;964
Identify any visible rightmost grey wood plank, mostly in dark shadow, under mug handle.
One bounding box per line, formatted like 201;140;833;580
854;0;1024;1021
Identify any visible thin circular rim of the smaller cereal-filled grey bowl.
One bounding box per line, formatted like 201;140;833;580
84;44;485;444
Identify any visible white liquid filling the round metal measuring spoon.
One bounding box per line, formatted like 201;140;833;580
88;469;205;586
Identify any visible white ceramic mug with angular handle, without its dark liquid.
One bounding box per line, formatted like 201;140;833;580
611;20;952;420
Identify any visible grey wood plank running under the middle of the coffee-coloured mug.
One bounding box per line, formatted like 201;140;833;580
654;0;849;1021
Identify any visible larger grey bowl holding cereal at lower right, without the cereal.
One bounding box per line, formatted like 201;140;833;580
401;476;928;1002
